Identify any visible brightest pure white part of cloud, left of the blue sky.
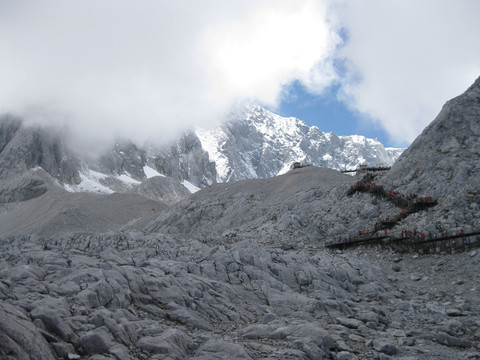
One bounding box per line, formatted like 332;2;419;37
202;0;341;106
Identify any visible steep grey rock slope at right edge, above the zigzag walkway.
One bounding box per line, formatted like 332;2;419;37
385;75;480;235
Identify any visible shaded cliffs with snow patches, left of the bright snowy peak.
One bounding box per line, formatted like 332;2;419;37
0;115;201;204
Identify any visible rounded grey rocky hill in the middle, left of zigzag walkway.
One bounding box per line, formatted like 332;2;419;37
147;167;370;242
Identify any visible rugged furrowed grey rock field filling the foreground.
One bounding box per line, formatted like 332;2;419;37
0;232;480;359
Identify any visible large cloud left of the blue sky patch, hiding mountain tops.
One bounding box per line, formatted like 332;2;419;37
0;0;340;148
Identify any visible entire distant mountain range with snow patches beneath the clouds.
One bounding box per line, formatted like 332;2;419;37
0;106;403;202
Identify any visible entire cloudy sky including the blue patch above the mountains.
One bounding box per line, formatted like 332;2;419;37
0;0;480;145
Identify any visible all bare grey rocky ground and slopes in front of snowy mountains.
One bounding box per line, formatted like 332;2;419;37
0;80;480;360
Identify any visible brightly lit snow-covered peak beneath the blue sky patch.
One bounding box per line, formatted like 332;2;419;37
196;106;403;182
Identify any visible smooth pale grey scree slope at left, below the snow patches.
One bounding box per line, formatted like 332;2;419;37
0;171;166;236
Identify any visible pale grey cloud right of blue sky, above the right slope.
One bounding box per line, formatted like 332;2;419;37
336;0;480;144
